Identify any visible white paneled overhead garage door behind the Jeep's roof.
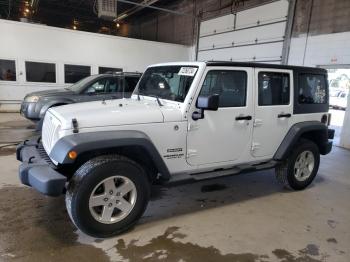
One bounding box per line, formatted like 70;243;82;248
197;0;289;63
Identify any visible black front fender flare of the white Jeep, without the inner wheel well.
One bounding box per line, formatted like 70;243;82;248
49;130;170;179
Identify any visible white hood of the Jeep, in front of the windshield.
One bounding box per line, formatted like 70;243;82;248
49;99;181;129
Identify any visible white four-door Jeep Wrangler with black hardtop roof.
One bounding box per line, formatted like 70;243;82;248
17;62;334;237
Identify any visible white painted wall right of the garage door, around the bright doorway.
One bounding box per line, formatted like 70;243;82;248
288;32;350;148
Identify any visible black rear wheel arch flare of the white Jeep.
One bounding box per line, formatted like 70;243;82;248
273;121;329;161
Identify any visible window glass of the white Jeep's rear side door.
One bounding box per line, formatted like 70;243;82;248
258;72;290;106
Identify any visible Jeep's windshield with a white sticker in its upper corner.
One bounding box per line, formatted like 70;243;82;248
135;66;198;102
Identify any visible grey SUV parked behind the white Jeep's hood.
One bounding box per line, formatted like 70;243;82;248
20;72;141;121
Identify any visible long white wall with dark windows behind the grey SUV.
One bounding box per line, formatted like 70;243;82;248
0;20;190;106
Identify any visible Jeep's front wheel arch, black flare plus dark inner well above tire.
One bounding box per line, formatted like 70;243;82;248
50;131;170;181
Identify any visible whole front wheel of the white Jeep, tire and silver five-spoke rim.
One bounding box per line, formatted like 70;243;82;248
66;155;150;237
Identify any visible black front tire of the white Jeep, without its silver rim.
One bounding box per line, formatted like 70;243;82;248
66;155;150;237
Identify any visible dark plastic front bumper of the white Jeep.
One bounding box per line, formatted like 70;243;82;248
16;137;67;196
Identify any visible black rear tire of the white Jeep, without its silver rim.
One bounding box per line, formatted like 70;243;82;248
275;139;320;190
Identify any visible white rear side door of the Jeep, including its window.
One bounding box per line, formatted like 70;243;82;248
252;68;293;157
